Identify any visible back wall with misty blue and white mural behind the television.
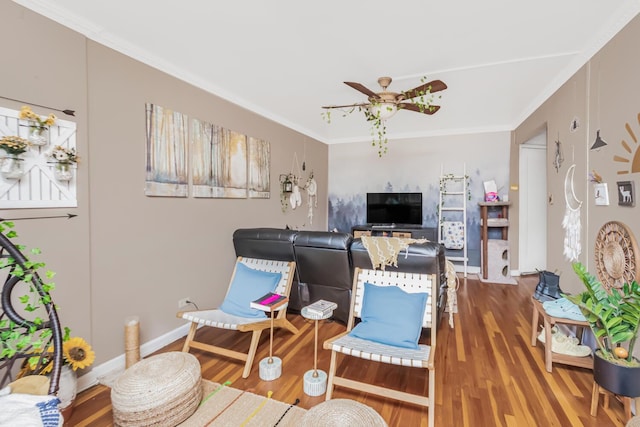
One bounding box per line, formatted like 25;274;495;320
328;132;510;266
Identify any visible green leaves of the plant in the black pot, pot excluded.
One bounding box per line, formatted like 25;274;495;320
563;263;640;366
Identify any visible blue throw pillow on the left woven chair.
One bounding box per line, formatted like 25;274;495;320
220;262;282;319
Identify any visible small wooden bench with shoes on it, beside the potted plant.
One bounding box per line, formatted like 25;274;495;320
531;297;593;372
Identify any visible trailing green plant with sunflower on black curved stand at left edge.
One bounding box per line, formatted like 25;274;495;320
0;220;95;417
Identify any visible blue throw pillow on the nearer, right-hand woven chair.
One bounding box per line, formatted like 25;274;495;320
349;283;429;349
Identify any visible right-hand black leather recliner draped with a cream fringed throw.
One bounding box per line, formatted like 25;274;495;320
351;238;447;326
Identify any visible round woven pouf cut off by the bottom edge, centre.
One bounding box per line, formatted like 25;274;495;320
300;399;387;427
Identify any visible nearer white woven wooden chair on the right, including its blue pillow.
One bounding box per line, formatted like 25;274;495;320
324;268;439;426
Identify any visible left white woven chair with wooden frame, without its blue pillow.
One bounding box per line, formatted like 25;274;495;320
177;257;298;378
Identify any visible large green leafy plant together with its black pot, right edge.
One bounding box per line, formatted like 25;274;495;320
564;263;640;397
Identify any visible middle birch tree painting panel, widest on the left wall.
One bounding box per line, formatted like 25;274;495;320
191;119;247;199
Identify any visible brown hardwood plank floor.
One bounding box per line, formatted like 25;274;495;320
65;276;625;427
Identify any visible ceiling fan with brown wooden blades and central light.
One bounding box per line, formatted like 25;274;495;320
322;77;447;120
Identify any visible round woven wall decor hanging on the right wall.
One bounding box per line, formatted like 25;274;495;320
595;221;640;289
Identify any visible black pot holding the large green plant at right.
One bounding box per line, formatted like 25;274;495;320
593;350;640;397
